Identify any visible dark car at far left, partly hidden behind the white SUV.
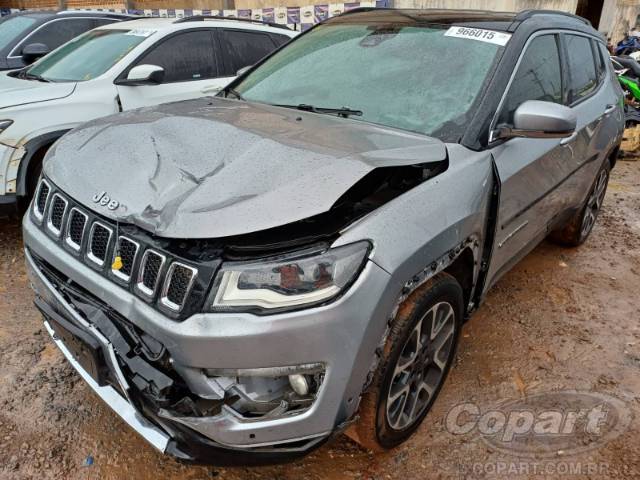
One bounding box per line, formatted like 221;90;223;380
0;11;133;70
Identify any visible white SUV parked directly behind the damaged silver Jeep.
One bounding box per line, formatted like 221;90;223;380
0;16;297;213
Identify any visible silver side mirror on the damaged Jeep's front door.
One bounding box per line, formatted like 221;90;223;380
498;100;578;138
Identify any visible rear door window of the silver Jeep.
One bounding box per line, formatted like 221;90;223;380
565;35;598;103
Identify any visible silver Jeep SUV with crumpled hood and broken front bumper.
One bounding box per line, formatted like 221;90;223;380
24;9;623;464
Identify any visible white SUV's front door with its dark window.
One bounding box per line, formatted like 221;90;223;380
117;28;230;110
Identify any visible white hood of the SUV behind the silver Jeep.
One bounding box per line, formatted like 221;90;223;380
0;72;76;109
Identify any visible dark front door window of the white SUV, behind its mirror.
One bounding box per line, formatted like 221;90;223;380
136;30;218;83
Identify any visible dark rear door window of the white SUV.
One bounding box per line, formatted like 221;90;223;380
220;30;276;75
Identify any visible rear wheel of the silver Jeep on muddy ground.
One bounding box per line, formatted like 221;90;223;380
549;160;611;247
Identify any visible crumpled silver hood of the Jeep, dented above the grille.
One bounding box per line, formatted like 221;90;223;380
44;98;446;238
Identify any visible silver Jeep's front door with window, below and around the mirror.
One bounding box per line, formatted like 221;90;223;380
487;33;576;286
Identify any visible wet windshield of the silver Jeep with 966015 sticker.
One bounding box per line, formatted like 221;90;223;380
235;23;503;140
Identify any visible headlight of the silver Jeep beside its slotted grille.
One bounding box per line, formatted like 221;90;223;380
211;242;370;311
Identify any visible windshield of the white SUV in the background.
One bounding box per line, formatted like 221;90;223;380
26;29;148;82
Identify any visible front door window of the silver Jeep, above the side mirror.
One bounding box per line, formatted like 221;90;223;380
498;35;562;124
